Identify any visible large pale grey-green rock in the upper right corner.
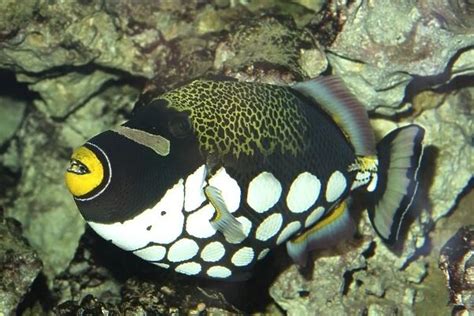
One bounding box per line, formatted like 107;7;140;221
328;0;474;114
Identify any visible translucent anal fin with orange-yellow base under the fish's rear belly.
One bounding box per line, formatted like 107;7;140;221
286;200;355;267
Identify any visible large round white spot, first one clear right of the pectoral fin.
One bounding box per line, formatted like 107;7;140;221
247;171;282;213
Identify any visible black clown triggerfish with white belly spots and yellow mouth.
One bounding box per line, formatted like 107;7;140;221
65;76;425;281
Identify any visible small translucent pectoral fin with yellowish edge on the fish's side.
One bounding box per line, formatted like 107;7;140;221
204;186;246;244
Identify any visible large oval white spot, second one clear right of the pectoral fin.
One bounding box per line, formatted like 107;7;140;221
286;172;321;213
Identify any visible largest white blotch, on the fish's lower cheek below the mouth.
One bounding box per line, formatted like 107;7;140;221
88;179;184;251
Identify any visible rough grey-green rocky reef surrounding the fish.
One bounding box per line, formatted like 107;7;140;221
0;0;474;315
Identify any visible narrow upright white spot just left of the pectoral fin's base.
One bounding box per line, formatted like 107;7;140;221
184;165;206;212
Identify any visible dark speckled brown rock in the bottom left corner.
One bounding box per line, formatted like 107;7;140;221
0;207;42;315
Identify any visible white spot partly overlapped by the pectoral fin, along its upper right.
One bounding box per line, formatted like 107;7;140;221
209;168;241;213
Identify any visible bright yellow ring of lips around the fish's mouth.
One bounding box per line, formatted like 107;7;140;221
65;146;104;197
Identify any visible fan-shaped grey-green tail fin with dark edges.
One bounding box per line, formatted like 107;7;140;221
368;125;425;244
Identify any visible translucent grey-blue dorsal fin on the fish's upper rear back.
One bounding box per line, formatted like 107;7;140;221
292;76;376;156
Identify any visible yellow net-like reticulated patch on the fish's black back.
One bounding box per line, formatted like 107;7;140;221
159;80;308;158
